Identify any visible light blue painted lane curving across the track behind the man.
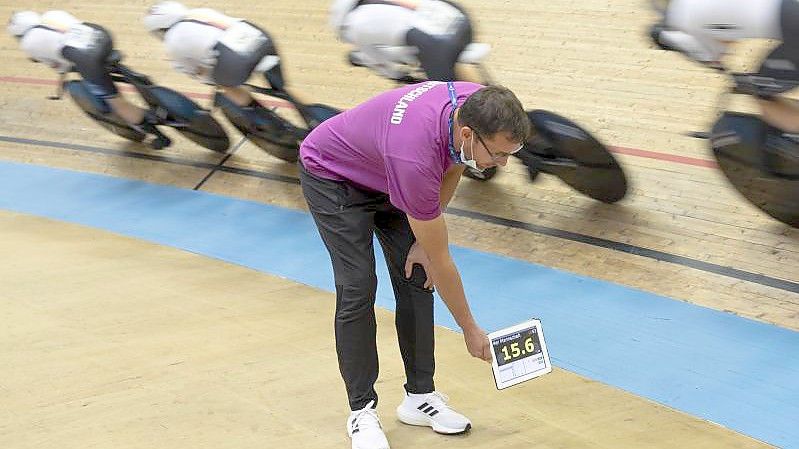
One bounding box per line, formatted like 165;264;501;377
0;159;799;449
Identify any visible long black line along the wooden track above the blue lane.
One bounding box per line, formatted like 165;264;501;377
0;135;799;293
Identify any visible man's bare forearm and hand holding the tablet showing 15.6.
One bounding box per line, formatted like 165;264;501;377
408;214;491;361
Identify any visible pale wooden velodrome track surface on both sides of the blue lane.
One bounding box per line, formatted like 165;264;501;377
0;0;799;448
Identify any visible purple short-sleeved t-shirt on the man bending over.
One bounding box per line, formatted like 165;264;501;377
300;81;483;220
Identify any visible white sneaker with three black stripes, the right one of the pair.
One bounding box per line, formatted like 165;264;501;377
397;391;472;435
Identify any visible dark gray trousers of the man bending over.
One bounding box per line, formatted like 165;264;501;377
299;164;435;410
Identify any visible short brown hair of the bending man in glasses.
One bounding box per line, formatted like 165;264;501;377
458;86;530;142
